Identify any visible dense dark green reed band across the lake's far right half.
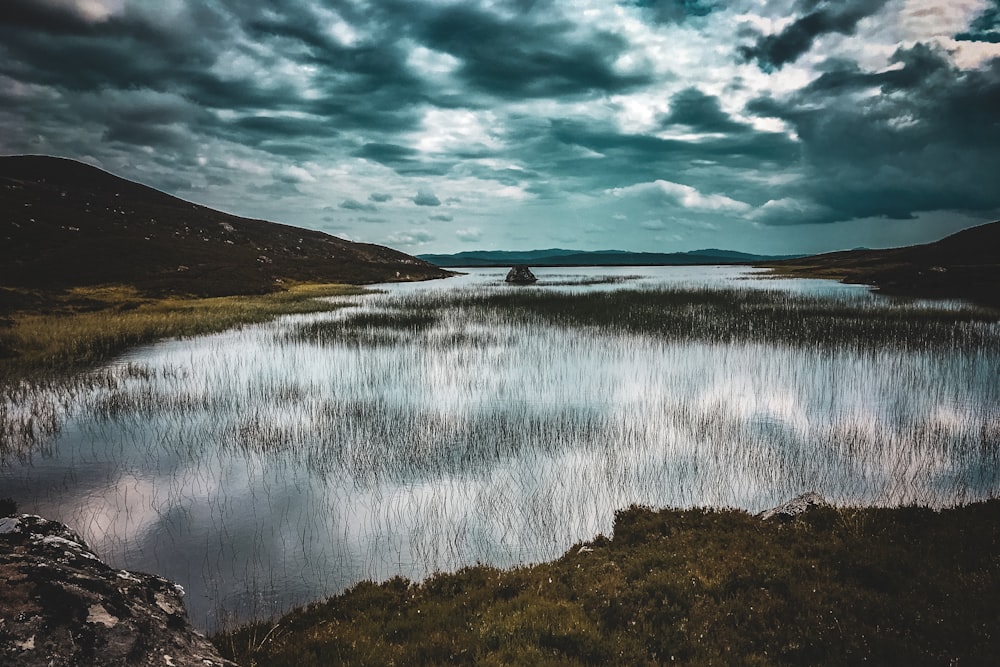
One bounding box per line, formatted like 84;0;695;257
388;288;1000;349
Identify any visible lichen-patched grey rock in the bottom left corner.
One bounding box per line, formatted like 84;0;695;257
0;515;234;667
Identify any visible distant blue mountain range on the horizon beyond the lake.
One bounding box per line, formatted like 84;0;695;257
417;248;802;268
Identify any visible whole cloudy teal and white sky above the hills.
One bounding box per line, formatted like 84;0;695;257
0;0;1000;253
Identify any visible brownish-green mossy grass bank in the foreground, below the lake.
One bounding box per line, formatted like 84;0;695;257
213;501;1000;667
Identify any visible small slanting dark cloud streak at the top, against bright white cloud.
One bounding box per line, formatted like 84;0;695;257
738;0;887;71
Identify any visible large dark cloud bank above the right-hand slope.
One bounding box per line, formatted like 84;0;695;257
749;44;1000;222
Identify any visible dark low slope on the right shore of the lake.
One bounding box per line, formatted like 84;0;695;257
764;221;1000;307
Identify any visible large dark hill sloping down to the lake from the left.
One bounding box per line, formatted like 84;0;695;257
0;156;450;296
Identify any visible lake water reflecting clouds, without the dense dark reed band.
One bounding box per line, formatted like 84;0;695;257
0;267;1000;630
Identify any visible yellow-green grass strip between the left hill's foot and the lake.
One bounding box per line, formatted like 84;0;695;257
0;284;361;384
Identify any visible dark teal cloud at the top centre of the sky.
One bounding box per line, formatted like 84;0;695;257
412;5;649;98
